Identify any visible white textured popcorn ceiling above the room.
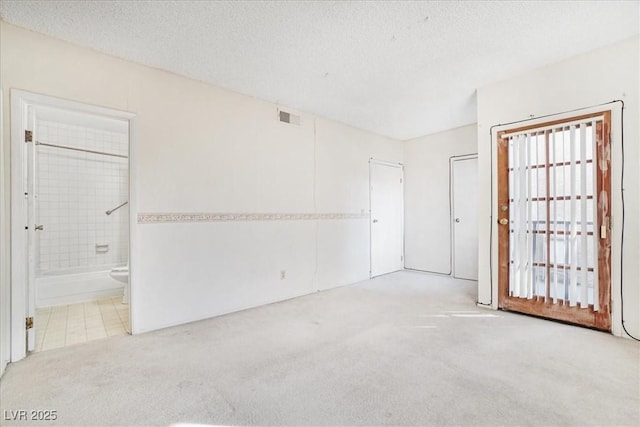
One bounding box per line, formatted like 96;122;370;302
0;0;640;140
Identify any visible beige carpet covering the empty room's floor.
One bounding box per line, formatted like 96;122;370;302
0;272;640;426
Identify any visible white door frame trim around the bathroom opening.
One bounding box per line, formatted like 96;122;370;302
9;89;138;362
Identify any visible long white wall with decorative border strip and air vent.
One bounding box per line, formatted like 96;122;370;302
0;23;402;333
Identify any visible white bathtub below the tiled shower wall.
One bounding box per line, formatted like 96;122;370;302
36;268;124;307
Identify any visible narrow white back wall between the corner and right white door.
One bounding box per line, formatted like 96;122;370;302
404;125;478;274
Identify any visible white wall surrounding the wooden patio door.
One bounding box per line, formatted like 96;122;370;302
478;37;640;337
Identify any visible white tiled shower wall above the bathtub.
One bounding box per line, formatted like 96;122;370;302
35;121;129;274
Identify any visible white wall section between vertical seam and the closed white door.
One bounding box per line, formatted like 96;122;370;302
315;119;402;289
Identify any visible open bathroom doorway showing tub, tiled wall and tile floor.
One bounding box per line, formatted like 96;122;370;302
11;91;132;361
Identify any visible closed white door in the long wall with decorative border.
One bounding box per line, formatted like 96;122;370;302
369;160;404;277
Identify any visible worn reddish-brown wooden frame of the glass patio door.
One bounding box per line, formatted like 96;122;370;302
495;110;612;331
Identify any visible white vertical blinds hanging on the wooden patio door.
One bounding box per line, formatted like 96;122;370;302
504;117;602;311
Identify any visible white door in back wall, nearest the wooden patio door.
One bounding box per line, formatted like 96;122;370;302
451;157;478;280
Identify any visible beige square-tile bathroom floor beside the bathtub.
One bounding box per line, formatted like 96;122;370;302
33;296;129;351
